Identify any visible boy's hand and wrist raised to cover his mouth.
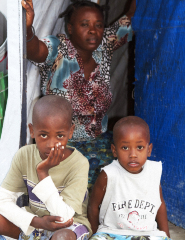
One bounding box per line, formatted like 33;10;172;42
37;143;64;181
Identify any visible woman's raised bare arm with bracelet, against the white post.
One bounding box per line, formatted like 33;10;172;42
21;0;48;63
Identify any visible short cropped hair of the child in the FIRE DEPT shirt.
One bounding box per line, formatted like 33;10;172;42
113;116;150;143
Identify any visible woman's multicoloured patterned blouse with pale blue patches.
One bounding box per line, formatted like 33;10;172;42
34;16;132;141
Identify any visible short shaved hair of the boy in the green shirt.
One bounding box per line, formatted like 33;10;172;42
32;95;73;125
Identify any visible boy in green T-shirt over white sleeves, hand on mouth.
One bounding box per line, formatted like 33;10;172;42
0;95;91;240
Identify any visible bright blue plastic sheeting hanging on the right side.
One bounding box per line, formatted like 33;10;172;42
133;0;185;228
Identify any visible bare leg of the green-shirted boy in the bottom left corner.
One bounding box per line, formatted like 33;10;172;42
0;215;21;239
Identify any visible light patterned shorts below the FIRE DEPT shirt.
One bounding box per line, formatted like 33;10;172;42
90;232;171;240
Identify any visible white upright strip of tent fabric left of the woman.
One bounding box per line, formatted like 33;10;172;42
0;0;22;182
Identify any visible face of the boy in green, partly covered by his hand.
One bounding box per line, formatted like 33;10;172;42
29;115;74;160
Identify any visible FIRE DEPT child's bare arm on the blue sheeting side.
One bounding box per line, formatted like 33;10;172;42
156;185;170;238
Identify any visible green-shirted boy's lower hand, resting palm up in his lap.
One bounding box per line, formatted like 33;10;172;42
30;216;73;232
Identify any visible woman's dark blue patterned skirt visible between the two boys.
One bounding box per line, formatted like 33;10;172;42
68;132;114;193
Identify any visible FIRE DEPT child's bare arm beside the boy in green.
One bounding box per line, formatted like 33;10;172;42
87;170;107;233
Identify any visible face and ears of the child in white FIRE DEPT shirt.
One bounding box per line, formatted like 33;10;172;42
111;126;152;174
